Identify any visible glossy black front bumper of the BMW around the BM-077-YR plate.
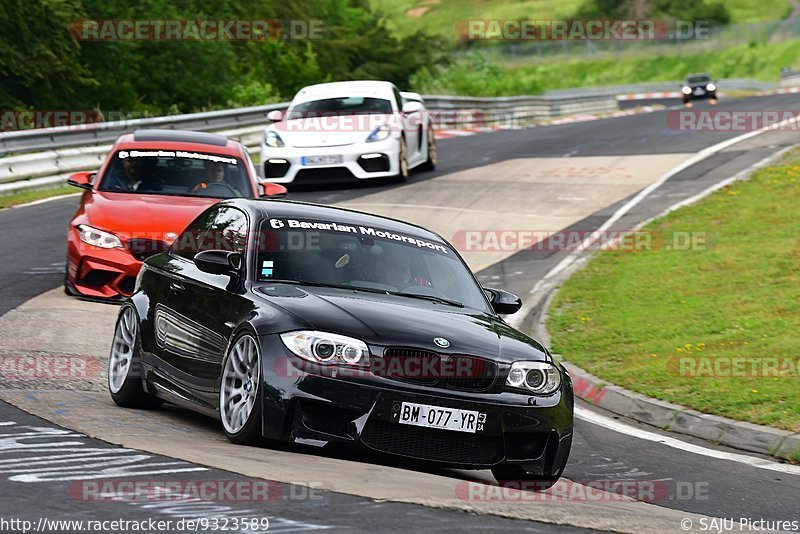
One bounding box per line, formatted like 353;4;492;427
261;336;574;476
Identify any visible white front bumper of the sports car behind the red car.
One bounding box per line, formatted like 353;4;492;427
260;137;400;184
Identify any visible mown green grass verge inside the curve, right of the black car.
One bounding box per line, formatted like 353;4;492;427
548;151;800;432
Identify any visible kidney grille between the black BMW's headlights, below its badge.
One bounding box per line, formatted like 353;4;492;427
372;347;497;391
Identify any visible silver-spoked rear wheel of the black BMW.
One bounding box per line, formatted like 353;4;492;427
108;305;163;409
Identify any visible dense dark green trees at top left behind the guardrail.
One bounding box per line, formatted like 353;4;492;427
0;0;447;113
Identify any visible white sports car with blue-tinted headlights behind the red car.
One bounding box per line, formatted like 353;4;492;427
261;81;437;183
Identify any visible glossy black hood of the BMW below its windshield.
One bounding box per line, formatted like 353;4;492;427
256;284;549;362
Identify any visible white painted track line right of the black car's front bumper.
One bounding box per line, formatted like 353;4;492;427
575;406;800;475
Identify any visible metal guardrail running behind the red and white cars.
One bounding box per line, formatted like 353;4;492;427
0;95;619;193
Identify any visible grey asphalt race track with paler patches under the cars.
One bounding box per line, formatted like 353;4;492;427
0;95;800;532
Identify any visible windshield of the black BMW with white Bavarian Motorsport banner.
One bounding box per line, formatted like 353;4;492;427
256;218;488;311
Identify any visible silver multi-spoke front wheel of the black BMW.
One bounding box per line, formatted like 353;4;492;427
219;332;264;445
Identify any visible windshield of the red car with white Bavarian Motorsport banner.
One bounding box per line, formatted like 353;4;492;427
98;150;253;198
